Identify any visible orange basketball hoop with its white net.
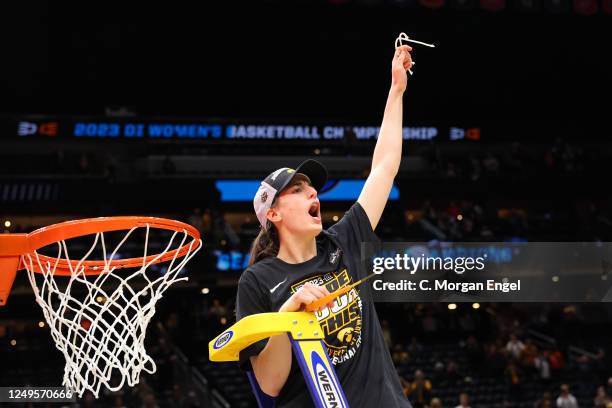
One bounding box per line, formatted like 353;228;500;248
0;217;202;398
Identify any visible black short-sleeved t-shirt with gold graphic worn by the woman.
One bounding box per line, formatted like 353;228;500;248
236;203;410;408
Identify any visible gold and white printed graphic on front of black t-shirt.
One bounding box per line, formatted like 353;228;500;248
291;268;362;365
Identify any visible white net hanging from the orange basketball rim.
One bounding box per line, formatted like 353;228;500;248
23;225;201;398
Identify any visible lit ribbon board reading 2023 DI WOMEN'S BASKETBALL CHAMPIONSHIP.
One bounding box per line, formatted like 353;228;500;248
0;116;481;144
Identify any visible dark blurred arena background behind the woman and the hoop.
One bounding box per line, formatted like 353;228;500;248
0;0;612;408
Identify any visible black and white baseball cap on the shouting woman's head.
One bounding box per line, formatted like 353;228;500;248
253;159;327;229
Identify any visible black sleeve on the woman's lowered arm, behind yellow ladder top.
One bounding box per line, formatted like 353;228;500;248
236;269;270;371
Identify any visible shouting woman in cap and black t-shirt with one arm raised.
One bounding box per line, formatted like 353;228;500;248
236;45;412;408
